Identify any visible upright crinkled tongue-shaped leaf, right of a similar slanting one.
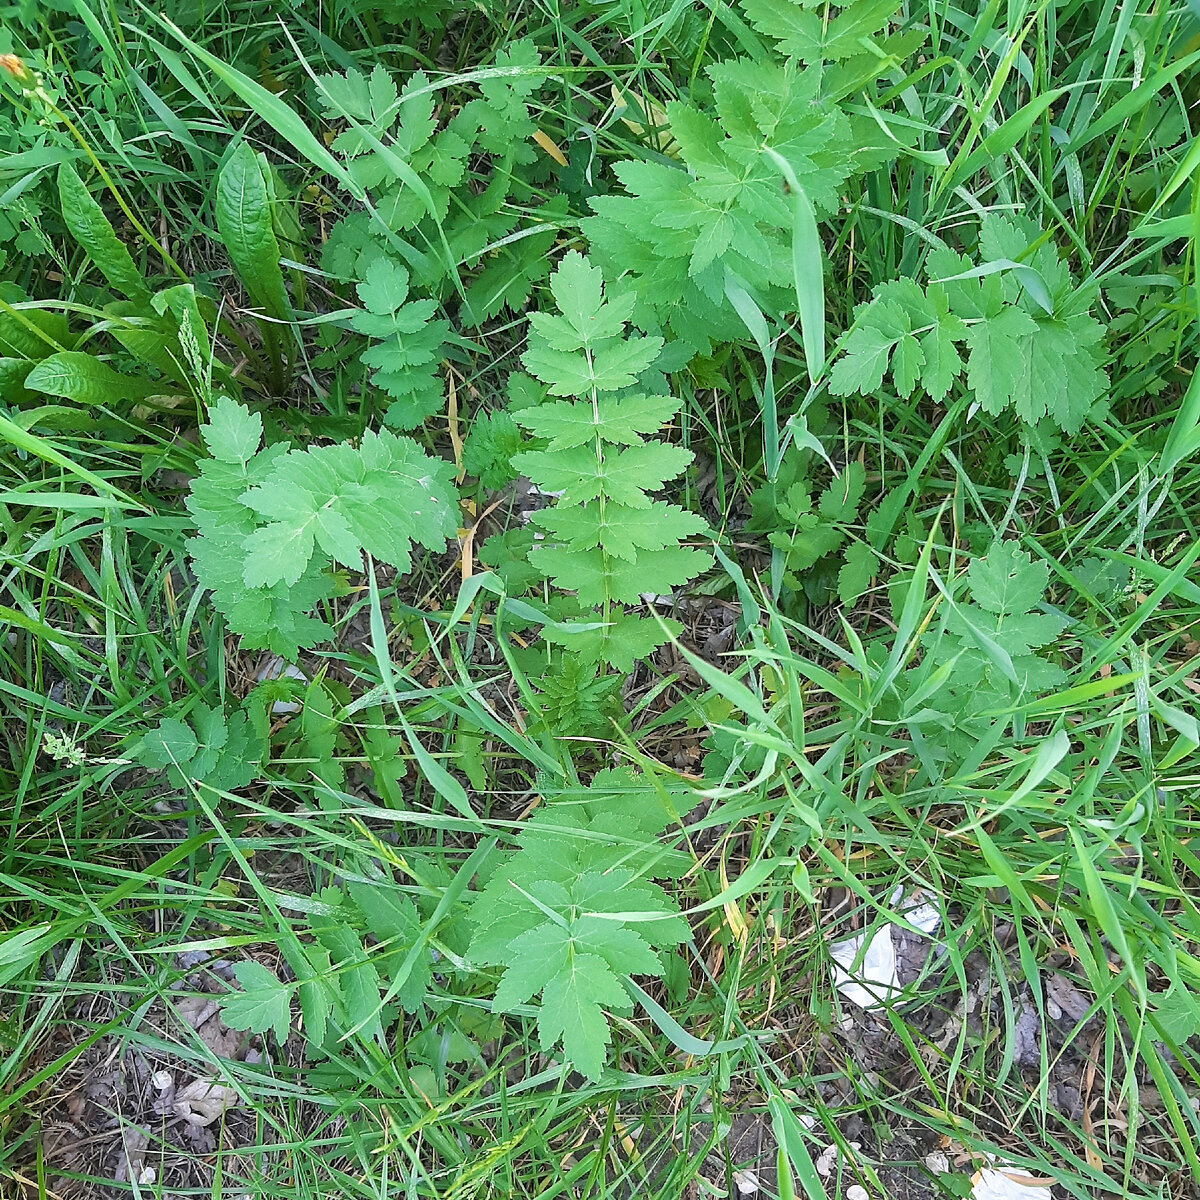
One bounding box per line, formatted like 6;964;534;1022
216;142;292;319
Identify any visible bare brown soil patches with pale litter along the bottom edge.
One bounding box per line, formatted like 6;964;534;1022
11;892;1200;1200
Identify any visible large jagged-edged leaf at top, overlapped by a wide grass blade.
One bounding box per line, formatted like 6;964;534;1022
583;58;877;350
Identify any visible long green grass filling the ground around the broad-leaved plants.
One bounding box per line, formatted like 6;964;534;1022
0;0;1200;1200
